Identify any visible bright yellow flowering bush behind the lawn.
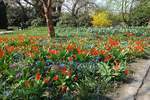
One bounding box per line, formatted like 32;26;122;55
91;12;112;27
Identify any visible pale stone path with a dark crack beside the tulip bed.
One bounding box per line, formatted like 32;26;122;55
111;59;150;100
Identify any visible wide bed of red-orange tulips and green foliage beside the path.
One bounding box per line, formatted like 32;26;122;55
0;29;150;100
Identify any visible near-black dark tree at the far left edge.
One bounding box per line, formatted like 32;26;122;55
0;0;8;29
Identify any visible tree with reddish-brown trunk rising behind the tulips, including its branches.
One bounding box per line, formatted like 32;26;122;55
6;0;64;37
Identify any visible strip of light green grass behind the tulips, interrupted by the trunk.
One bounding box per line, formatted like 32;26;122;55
0;27;147;36
